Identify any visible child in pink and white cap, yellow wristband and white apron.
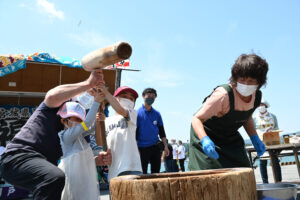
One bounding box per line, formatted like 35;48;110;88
57;102;100;200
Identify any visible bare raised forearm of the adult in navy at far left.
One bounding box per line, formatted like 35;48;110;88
45;81;91;108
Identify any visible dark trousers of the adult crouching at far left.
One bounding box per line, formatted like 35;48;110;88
0;151;65;200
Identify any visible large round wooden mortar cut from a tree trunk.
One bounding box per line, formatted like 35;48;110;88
110;168;257;200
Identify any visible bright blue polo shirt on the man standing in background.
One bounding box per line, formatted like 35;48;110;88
137;105;163;148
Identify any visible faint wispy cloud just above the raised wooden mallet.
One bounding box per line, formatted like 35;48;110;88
67;31;116;48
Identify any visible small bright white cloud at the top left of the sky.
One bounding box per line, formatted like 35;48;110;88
36;0;65;20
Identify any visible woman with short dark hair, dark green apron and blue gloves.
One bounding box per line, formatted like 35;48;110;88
189;54;268;170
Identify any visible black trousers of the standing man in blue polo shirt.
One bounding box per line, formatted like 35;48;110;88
139;145;162;174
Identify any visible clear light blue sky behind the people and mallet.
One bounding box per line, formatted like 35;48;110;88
0;0;300;141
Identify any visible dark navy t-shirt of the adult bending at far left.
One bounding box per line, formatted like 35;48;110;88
4;102;64;165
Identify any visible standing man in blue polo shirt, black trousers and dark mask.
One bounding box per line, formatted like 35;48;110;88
136;88;169;174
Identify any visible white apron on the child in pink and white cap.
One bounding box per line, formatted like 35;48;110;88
58;140;100;200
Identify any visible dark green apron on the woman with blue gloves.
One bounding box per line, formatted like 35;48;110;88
189;84;261;171
